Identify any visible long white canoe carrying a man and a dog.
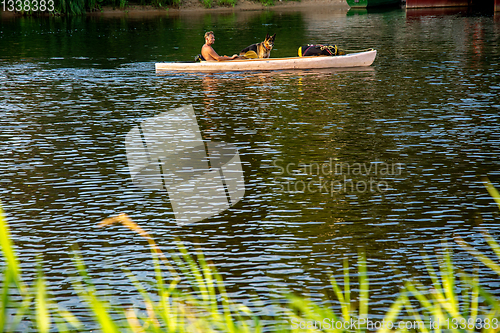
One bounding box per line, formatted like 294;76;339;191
155;50;377;72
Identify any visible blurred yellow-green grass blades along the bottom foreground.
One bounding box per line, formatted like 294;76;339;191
0;181;500;333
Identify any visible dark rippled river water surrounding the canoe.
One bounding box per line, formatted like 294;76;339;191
0;4;500;326
